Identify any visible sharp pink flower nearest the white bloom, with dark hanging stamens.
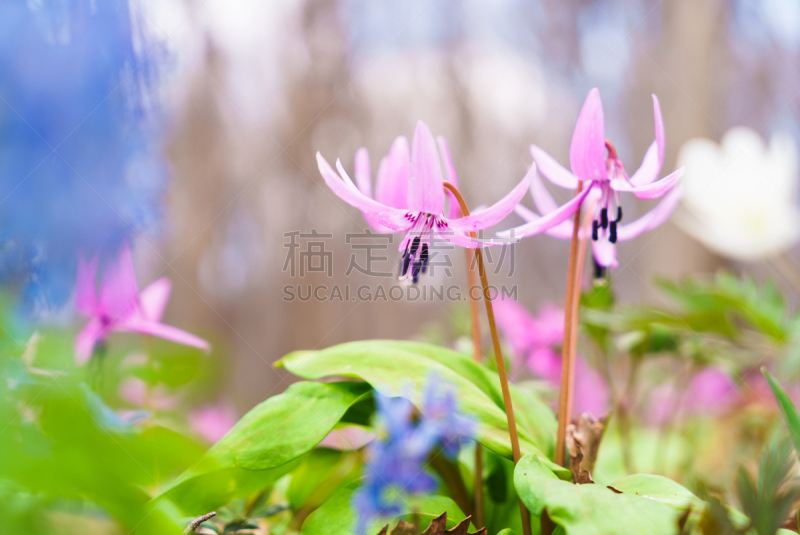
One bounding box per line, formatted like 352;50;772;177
498;88;684;267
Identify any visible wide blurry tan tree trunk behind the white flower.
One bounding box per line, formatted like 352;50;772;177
629;0;728;299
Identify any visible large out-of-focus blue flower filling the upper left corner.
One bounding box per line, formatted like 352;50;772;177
0;0;166;309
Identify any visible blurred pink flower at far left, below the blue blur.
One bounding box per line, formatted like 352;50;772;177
75;243;210;364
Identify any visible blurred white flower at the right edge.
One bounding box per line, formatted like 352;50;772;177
676;127;800;260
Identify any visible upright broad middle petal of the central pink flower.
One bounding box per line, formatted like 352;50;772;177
408;121;444;215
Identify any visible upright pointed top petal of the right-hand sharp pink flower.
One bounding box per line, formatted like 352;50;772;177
569;87;607;180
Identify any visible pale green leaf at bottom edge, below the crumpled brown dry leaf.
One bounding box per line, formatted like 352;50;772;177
514;455;681;535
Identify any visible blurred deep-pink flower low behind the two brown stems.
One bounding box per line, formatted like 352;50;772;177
494;299;608;416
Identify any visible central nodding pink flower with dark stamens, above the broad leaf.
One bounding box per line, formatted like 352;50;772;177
317;121;535;283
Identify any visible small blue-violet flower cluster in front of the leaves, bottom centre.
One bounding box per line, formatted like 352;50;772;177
353;376;475;533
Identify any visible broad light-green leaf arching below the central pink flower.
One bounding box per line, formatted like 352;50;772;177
280;341;571;477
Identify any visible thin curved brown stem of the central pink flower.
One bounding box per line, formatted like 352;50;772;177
444;182;531;535
